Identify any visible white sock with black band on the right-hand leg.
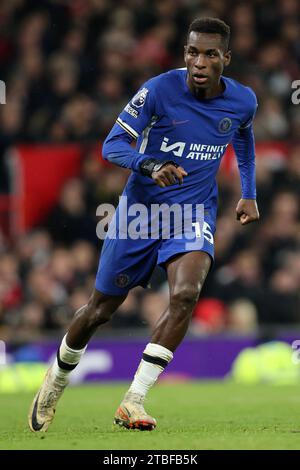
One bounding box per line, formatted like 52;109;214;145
128;343;173;396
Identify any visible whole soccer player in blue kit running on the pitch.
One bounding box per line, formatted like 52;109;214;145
29;18;259;431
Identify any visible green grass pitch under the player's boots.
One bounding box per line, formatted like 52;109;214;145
0;382;300;450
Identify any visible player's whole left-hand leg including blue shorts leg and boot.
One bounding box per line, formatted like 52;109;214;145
29;229;157;431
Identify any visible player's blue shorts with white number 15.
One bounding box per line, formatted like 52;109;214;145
95;212;215;295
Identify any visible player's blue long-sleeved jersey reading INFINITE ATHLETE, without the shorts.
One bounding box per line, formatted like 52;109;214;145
104;68;257;210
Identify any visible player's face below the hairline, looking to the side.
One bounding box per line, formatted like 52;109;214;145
184;31;230;97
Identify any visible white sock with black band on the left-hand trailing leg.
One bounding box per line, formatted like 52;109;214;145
51;335;86;383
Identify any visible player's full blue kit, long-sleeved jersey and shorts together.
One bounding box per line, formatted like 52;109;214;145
95;69;257;295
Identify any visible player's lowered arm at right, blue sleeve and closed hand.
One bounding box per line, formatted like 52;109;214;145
232;94;259;225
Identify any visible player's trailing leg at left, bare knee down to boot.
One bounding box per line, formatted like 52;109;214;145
28;289;126;432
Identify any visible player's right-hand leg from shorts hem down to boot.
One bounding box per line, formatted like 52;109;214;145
115;251;211;430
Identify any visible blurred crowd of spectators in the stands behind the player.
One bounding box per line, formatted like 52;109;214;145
0;0;300;339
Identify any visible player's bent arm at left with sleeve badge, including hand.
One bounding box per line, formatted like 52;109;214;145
102;78;187;188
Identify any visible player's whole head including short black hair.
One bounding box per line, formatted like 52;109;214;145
184;18;231;90
